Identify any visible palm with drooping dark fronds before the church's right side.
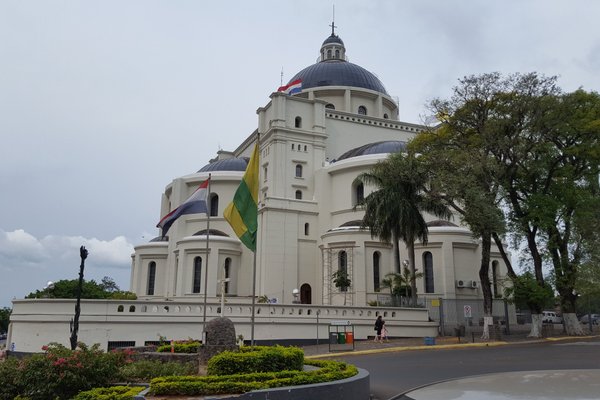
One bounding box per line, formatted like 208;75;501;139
357;153;452;307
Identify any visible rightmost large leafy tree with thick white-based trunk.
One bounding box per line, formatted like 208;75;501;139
497;87;600;335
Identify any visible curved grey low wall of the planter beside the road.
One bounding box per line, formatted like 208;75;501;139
205;368;371;400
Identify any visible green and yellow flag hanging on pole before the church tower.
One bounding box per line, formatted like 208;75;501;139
223;143;258;251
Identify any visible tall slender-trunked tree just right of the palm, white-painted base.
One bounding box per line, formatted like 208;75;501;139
409;74;515;339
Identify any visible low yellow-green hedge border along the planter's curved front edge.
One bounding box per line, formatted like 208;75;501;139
150;360;358;396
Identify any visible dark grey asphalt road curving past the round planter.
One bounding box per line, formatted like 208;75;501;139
339;338;600;400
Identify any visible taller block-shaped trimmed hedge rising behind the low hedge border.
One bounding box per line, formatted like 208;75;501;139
207;346;304;375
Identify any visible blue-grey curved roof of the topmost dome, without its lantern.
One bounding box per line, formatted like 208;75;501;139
289;59;388;95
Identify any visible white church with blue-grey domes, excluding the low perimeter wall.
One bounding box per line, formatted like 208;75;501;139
131;28;505;306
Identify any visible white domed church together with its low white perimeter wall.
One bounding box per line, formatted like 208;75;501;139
8;31;506;351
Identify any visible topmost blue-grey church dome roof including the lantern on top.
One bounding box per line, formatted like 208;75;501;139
288;28;388;95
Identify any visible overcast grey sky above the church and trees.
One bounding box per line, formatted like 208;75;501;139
0;0;600;307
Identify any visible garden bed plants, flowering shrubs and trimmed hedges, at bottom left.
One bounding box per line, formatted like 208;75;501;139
0;342;358;400
